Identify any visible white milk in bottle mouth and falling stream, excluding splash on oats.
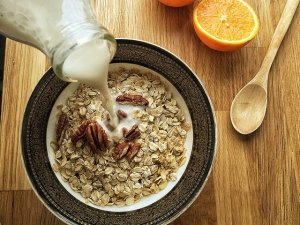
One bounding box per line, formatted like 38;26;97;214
63;40;118;127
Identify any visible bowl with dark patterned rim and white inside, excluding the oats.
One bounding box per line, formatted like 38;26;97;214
22;39;216;225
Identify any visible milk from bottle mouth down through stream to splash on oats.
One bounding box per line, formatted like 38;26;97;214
63;40;144;135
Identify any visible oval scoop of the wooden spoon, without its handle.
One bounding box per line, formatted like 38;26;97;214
230;83;267;134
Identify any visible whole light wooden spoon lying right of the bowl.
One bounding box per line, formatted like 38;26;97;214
230;0;300;134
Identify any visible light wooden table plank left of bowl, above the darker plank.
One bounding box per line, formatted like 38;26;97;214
0;40;45;190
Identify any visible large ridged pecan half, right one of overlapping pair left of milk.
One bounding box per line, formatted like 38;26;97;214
85;122;108;152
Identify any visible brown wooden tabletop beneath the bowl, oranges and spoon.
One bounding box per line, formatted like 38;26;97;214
0;0;300;225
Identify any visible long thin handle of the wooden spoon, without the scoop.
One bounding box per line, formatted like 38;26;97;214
253;0;300;88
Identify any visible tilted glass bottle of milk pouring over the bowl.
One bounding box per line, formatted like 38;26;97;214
0;0;116;83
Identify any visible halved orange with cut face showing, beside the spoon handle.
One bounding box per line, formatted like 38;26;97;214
193;0;259;51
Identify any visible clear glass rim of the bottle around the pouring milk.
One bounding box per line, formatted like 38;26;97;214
52;27;117;82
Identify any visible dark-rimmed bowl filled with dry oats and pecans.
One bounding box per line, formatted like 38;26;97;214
22;39;216;224
